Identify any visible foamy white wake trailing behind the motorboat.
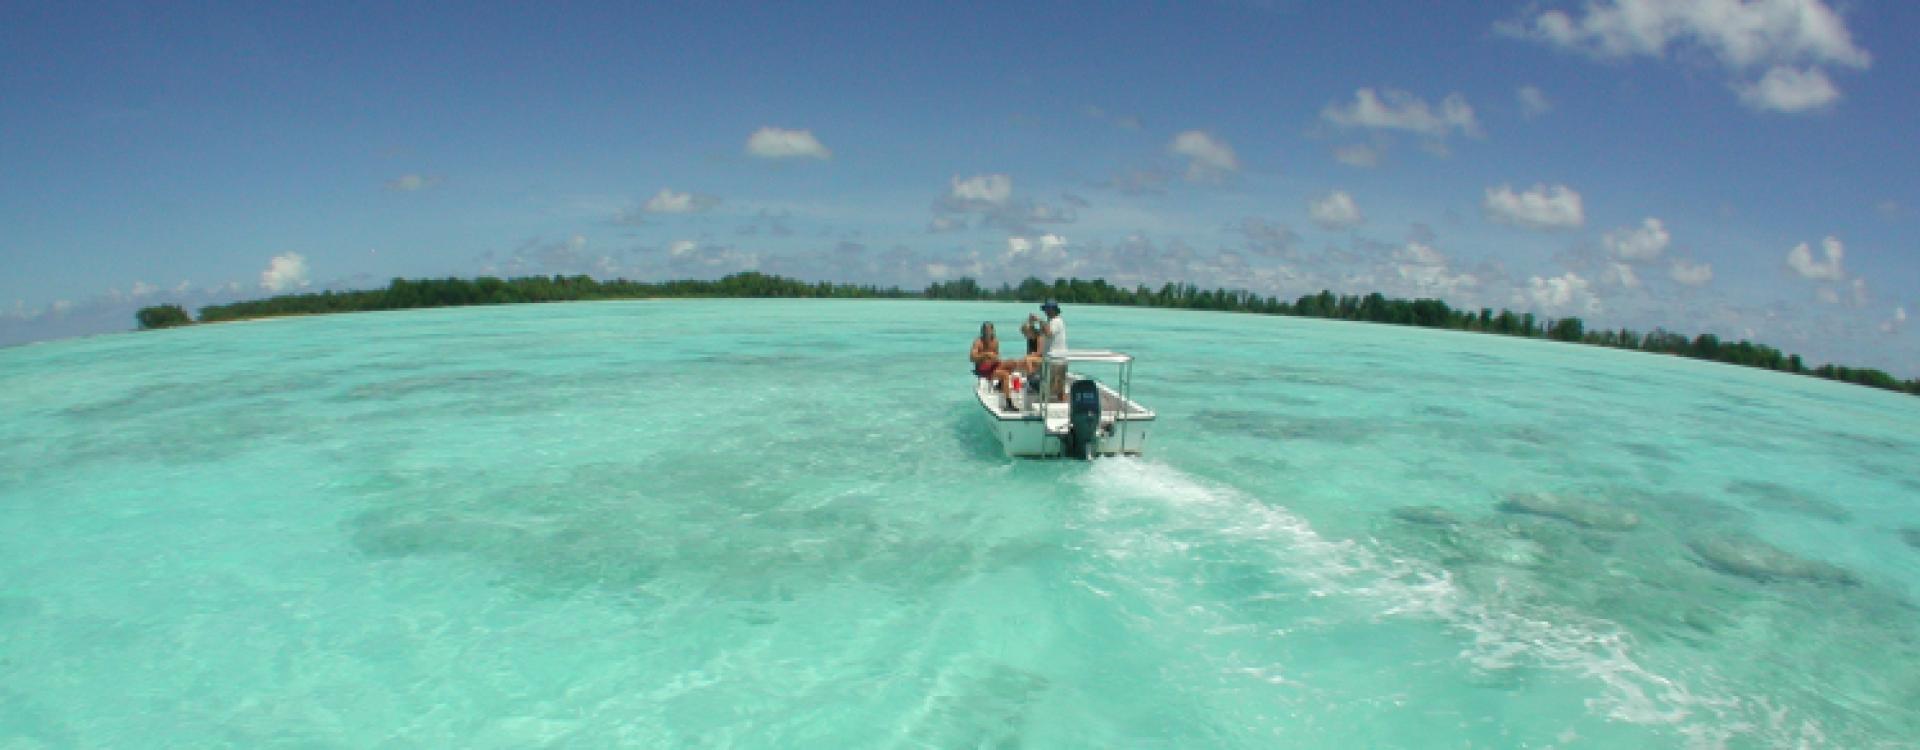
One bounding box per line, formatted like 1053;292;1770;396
1081;460;1828;748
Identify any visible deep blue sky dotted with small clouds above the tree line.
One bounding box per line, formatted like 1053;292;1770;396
0;0;1920;378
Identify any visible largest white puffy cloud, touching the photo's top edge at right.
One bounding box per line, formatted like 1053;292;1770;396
1496;0;1872;111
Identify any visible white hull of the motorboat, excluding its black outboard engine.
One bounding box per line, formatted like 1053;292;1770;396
973;378;1154;458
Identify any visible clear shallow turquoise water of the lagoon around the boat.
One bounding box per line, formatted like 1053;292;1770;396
0;301;1920;748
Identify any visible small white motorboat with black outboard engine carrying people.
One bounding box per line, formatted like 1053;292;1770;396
973;349;1154;458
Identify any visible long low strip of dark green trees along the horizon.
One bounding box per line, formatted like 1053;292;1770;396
138;270;1920;395
